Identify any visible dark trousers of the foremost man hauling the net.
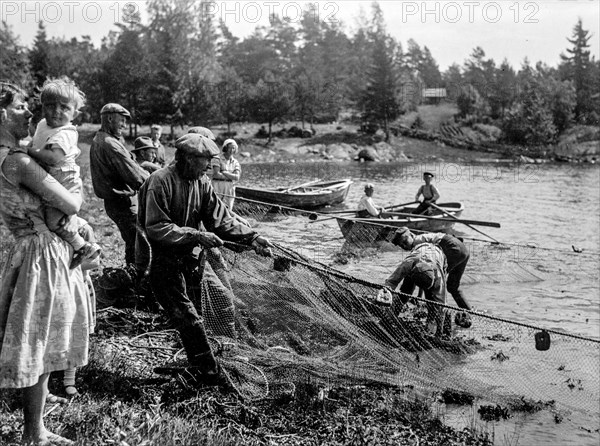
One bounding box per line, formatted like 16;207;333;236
150;255;217;372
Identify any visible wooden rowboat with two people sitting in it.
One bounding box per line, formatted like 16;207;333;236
336;203;464;244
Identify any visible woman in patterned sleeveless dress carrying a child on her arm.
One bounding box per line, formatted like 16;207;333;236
0;83;93;445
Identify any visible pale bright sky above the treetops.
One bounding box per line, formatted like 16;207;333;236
0;0;600;71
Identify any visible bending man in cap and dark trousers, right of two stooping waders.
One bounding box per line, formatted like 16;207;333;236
392;227;471;326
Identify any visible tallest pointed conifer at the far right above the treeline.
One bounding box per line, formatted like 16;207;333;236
560;19;600;124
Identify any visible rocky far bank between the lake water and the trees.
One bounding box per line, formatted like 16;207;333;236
232;124;600;164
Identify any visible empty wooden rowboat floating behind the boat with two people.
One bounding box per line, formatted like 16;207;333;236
235;179;352;209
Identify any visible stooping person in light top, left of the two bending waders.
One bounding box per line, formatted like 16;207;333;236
385;243;446;337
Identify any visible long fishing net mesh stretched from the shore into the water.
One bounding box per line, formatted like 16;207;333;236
151;199;600;416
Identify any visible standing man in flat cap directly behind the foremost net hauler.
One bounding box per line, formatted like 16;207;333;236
90;103;149;266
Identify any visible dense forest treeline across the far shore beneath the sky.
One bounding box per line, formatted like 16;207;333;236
0;0;600;145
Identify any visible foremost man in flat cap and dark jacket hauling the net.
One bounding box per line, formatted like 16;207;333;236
138;134;271;385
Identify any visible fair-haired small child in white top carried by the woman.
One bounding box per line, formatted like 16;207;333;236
29;78;100;269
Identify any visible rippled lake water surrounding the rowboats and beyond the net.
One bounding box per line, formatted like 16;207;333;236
241;163;600;445
